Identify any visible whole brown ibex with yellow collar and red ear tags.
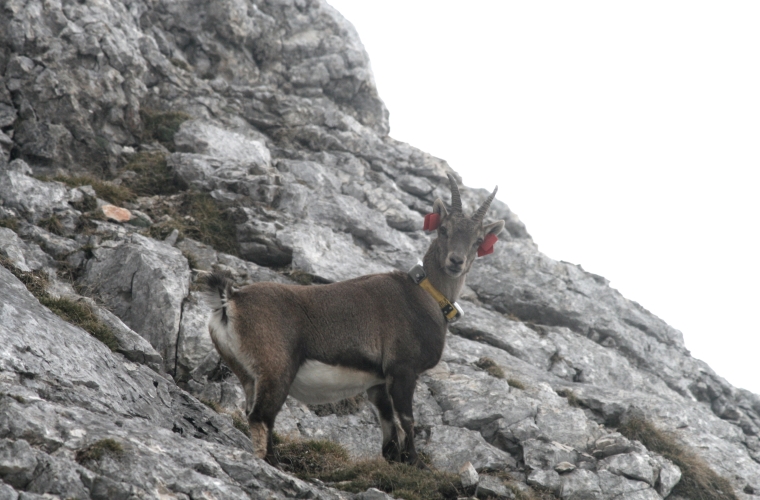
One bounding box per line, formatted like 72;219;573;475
207;175;504;467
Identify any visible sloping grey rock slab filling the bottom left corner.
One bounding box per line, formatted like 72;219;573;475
0;268;350;498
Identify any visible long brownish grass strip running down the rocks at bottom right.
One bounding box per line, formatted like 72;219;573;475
618;417;737;500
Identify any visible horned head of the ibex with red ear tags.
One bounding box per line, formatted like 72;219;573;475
431;174;504;278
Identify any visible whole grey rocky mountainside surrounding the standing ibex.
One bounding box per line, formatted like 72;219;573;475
0;0;760;499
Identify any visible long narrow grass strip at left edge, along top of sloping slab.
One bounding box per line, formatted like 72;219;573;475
0;256;119;351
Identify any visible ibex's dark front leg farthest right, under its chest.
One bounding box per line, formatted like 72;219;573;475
387;370;427;469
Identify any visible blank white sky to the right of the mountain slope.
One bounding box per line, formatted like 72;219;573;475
328;0;760;393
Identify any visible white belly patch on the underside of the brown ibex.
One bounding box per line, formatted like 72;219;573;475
290;359;385;404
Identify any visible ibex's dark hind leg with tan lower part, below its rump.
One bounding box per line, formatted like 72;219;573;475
246;377;290;466
